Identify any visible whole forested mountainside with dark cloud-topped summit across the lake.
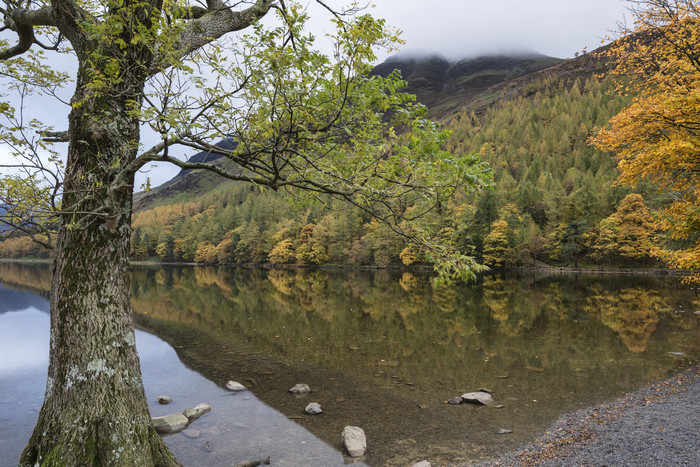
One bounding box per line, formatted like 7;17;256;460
52;42;658;267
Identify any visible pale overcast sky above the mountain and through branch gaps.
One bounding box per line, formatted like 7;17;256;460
0;0;627;189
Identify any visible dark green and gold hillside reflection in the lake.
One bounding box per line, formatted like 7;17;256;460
0;267;700;465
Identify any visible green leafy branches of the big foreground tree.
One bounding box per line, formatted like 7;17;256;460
0;0;491;279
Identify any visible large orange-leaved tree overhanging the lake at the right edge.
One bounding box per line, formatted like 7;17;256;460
592;0;700;281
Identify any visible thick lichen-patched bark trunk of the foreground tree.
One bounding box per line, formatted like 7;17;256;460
20;63;177;466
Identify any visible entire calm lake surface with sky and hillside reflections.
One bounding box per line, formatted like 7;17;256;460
0;263;700;466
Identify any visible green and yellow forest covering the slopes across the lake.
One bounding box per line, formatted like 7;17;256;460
83;74;657;267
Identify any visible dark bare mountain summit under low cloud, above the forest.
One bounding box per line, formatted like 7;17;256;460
372;52;562;118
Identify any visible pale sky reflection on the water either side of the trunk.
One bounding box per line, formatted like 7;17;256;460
0;268;356;466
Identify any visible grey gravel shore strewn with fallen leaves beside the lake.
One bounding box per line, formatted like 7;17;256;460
478;365;700;466
